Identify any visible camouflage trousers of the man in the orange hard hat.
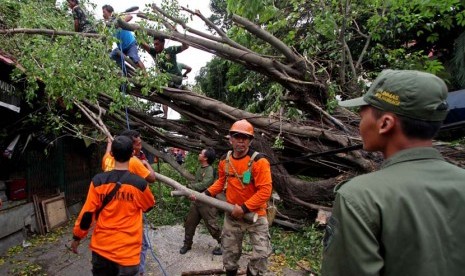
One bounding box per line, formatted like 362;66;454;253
221;215;271;275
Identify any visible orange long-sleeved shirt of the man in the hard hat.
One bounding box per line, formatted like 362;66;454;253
206;150;272;216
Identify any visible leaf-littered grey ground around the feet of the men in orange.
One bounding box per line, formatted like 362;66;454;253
0;223;305;276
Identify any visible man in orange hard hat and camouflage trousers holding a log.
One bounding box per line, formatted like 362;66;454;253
205;120;272;276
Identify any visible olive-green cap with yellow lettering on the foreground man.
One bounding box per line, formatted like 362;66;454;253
339;70;448;122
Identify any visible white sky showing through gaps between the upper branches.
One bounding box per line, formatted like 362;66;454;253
57;0;213;84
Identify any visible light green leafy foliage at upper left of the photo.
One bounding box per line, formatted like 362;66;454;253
0;0;167;141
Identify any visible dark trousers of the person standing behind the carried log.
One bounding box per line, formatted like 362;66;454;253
184;202;221;246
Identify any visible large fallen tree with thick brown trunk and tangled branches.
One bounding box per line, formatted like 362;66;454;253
0;3;463;220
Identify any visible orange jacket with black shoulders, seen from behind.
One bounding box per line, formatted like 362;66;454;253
73;170;155;266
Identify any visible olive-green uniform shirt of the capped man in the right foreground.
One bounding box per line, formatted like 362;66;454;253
323;148;465;275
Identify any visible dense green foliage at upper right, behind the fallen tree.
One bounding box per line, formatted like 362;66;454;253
198;0;465;113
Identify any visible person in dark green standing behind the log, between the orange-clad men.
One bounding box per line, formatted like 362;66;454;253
179;148;222;255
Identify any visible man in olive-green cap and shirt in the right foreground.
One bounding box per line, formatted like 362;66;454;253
322;70;465;276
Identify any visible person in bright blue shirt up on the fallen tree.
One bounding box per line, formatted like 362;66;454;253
102;5;145;71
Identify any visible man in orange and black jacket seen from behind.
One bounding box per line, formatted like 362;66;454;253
71;136;155;275
